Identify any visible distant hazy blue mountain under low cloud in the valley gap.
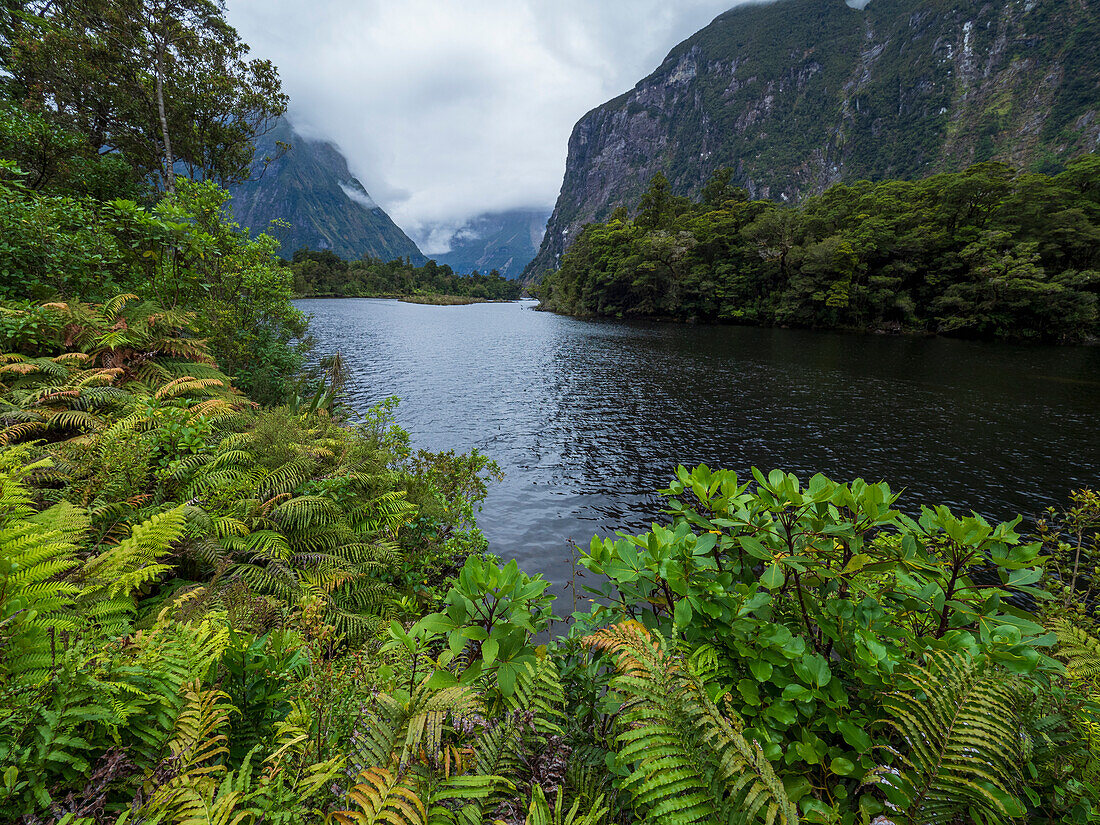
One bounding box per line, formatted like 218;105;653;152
435;209;550;278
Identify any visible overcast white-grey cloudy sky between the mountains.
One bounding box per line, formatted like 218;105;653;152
228;0;739;254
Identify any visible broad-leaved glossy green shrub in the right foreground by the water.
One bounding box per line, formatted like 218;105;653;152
563;466;1071;820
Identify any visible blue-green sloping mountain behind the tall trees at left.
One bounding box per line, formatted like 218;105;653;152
230;119;427;264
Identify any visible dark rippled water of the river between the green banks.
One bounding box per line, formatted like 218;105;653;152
299;299;1100;598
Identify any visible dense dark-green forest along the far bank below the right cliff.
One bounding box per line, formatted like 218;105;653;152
539;162;1100;341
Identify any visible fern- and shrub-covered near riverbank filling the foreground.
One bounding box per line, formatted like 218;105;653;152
0;298;1100;824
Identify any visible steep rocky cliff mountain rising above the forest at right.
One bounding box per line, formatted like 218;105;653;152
525;0;1100;277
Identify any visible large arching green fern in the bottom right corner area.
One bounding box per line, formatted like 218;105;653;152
873;651;1023;825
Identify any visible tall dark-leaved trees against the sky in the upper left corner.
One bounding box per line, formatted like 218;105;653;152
0;0;287;193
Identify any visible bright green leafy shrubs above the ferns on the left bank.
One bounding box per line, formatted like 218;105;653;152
0;124;309;403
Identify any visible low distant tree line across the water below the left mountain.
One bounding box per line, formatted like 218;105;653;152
288;250;523;300
